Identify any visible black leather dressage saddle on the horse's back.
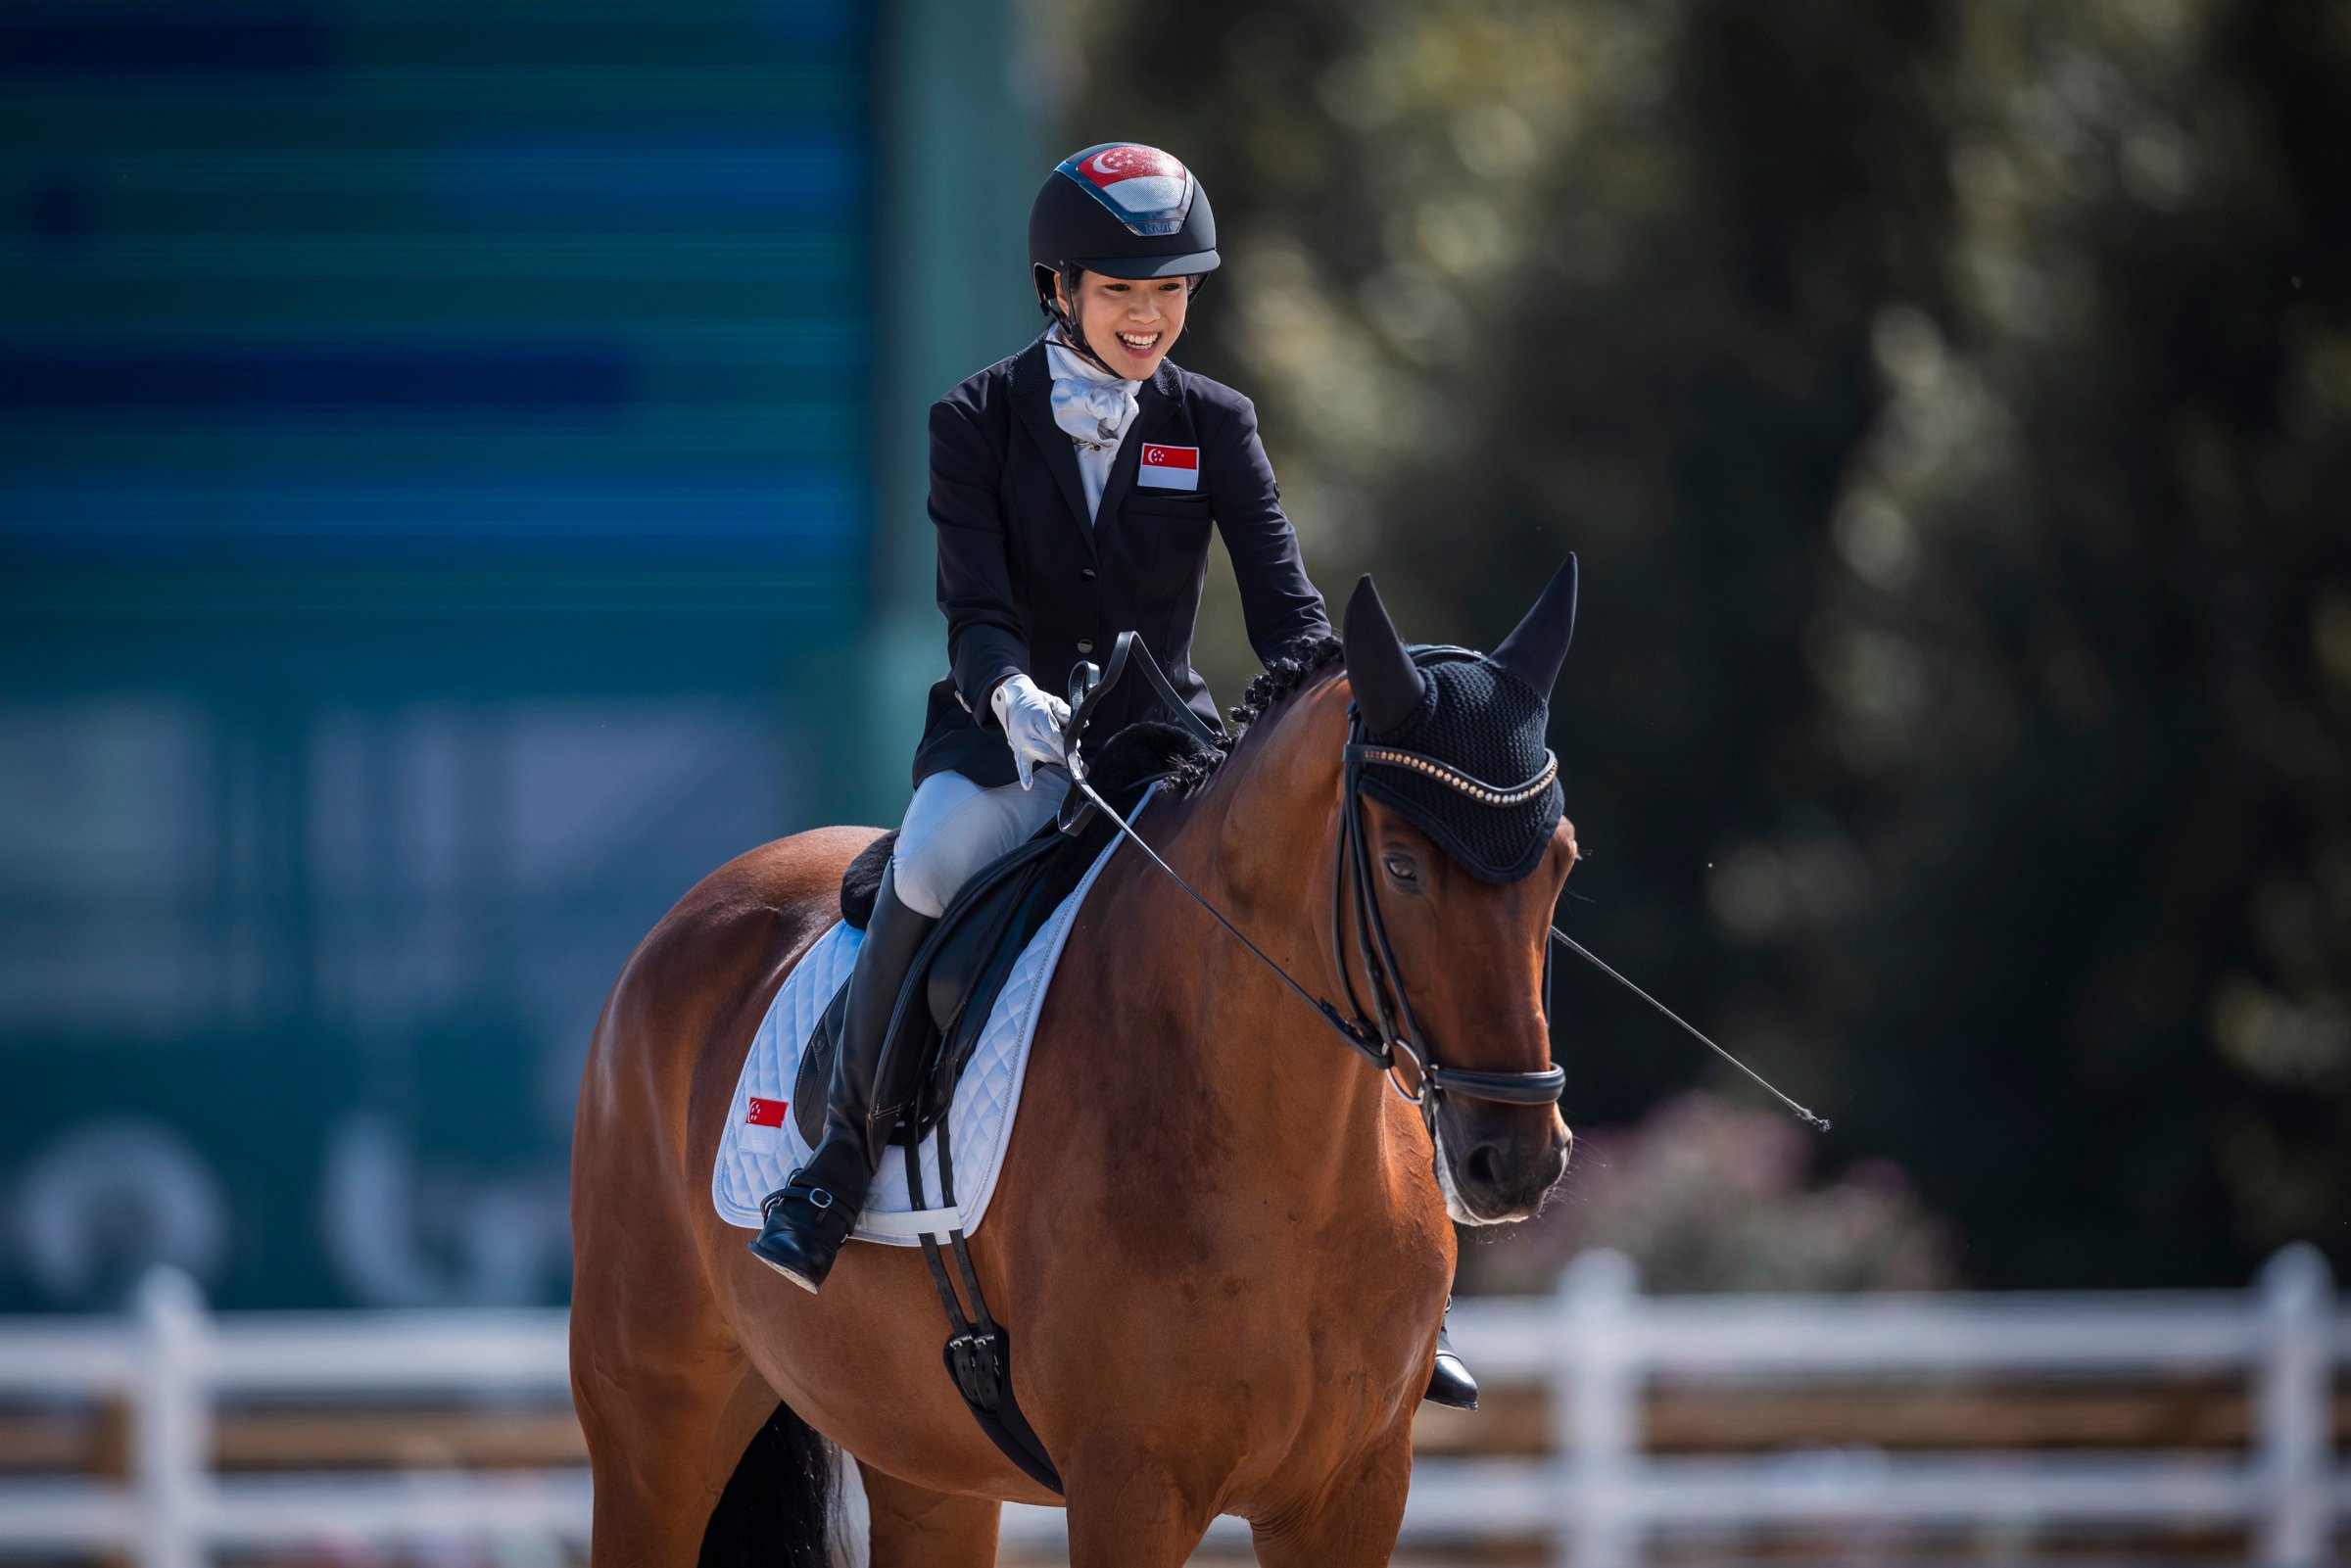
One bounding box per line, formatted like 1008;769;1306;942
792;719;1216;1147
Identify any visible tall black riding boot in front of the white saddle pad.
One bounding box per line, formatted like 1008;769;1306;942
750;868;938;1291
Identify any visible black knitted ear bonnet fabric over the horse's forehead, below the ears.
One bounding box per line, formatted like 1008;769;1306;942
1359;646;1565;881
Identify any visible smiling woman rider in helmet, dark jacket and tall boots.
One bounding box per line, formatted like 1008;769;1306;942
750;141;1476;1405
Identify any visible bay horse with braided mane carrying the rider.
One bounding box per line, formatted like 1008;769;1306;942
571;557;1575;1568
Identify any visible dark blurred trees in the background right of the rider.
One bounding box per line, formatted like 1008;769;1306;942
1067;0;2351;1284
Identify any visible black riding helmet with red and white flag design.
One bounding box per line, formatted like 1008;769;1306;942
1030;141;1218;374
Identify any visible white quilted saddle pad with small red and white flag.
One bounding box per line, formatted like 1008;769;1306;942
710;818;1119;1246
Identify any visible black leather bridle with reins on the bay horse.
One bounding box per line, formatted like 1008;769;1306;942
1060;633;1568;1123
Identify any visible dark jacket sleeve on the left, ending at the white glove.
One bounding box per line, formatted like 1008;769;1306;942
931;400;1030;729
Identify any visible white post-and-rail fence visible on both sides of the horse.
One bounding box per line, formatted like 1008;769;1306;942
0;1249;2351;1568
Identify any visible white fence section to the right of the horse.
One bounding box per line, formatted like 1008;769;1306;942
1406;1246;2351;1568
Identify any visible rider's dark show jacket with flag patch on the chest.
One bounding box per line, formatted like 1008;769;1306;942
915;339;1330;785
